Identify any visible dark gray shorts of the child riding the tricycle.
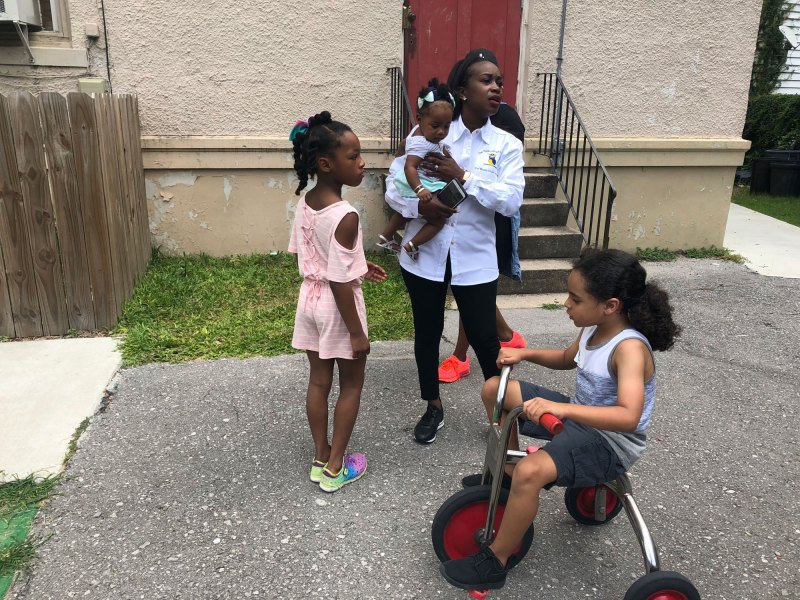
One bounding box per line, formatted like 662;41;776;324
519;381;625;487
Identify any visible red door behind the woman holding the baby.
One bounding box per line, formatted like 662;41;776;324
405;0;522;107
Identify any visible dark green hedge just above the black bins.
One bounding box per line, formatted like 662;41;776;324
742;94;800;163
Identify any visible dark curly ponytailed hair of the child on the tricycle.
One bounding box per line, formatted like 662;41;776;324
573;249;681;350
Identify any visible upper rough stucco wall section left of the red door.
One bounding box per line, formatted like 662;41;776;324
101;0;403;136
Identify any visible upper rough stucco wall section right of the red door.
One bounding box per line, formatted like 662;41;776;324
524;0;761;138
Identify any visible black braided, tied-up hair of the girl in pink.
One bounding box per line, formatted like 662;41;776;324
289;110;352;196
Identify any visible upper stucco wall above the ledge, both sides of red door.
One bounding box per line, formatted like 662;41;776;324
0;0;761;138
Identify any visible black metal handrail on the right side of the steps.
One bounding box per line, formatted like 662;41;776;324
537;73;617;248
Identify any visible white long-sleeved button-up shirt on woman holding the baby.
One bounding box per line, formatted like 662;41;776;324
386;117;525;285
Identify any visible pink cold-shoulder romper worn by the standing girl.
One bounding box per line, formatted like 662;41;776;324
289;196;368;360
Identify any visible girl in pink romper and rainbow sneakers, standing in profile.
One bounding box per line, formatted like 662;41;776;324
289;112;386;492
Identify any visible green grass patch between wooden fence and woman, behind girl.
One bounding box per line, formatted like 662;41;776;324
113;252;413;366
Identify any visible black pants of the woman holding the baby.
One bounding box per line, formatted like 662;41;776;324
402;257;500;401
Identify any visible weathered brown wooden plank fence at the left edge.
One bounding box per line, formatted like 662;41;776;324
0;92;150;338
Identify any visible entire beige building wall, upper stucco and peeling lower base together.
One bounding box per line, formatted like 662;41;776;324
0;0;760;254
